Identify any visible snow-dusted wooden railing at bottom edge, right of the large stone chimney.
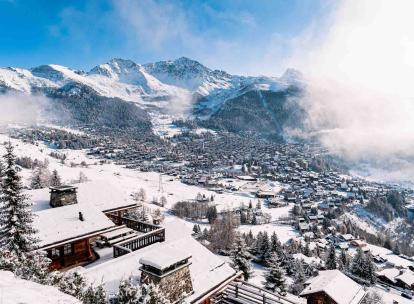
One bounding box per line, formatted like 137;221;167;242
217;281;305;304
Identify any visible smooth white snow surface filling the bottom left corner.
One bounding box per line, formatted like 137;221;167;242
0;271;81;304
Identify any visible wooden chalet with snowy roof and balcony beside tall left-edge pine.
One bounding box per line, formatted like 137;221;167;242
30;182;164;269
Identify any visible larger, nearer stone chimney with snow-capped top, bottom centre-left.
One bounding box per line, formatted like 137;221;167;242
139;249;194;303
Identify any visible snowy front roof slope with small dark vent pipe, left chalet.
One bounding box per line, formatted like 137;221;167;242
33;204;115;247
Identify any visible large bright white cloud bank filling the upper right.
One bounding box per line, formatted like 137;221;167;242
292;0;414;165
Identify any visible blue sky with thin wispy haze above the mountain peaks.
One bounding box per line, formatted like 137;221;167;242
0;0;336;75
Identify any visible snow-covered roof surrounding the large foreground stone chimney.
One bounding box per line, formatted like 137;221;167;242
83;219;236;300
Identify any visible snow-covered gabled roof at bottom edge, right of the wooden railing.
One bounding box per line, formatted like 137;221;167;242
300;270;365;304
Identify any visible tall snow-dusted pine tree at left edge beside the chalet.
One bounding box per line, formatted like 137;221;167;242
0;143;37;255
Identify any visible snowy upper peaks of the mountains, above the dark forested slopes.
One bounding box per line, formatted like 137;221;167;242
0;57;301;137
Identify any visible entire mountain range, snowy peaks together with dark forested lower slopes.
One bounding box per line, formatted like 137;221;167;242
0;57;304;136
